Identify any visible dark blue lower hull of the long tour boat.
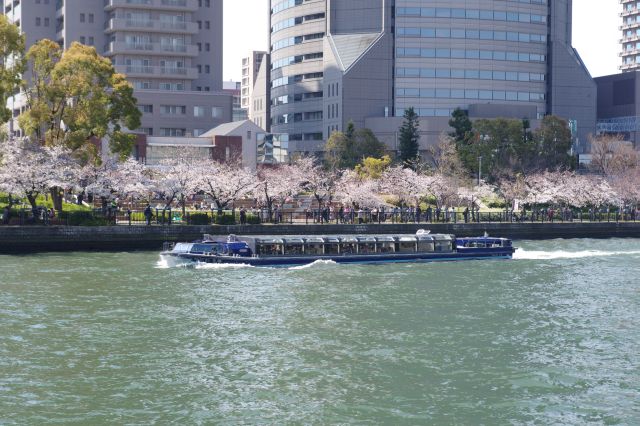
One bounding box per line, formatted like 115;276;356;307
162;248;514;267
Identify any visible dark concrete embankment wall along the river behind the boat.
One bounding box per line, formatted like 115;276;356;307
0;222;640;254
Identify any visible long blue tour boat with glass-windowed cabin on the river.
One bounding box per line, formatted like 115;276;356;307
161;230;515;267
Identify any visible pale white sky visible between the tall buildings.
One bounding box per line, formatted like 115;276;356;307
223;0;622;81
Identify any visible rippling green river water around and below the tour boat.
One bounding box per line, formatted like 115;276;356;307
0;239;640;425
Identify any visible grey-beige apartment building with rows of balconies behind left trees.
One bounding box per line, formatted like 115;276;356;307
3;0;232;136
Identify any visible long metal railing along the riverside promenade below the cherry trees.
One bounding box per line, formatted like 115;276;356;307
0;206;640;226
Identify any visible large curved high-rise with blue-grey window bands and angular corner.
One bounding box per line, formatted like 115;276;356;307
270;0;596;155
